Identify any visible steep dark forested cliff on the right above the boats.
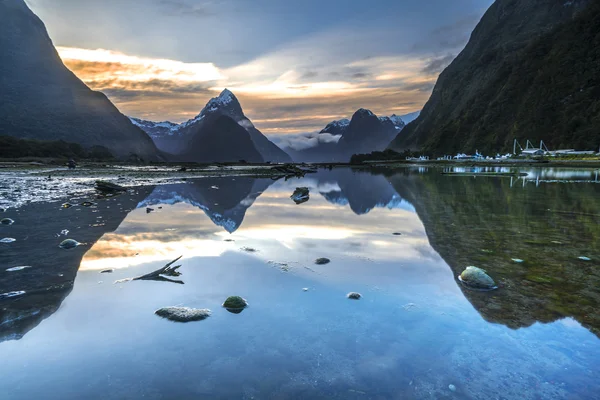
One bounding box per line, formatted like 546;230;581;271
390;0;600;155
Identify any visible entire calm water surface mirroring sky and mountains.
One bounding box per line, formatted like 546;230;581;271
0;168;600;400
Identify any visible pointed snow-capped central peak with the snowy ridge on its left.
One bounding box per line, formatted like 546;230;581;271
131;89;292;162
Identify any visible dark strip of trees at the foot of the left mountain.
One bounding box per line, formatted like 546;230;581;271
0;136;113;161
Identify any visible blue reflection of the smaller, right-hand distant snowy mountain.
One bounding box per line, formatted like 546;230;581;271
316;169;405;215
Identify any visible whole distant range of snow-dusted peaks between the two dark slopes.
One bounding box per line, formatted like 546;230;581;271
130;95;406;162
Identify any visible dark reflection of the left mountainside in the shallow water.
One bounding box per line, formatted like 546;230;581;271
0;188;152;342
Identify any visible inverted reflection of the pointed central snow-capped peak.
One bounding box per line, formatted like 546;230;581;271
138;177;273;233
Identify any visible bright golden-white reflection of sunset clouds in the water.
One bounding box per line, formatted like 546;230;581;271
82;178;446;294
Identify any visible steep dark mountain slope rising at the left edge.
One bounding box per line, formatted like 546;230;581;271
0;0;159;160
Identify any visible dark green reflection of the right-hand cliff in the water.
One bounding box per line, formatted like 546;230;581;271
390;172;600;335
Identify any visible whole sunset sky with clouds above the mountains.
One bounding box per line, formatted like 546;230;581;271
26;0;493;137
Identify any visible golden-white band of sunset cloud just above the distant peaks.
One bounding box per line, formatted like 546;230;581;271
59;46;437;129
